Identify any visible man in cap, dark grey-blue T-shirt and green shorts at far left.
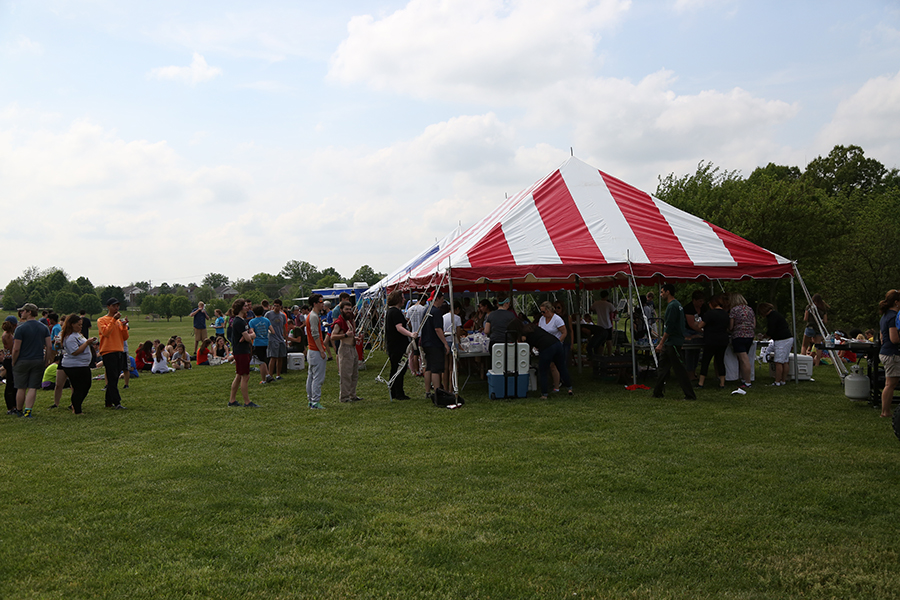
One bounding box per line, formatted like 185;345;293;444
12;303;53;417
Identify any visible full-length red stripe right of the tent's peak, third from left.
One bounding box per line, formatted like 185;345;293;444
600;171;693;264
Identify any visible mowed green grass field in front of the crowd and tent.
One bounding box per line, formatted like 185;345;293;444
0;320;900;599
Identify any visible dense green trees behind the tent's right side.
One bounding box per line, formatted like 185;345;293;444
656;146;900;333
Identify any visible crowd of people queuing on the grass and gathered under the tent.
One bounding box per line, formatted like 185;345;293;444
0;284;900;418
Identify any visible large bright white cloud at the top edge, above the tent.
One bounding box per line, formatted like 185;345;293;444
329;0;630;102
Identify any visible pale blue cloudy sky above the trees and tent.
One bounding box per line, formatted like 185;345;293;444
0;0;900;286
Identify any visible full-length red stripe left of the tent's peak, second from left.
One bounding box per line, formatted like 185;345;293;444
533;171;606;264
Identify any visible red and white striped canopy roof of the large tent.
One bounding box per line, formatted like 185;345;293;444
390;157;793;291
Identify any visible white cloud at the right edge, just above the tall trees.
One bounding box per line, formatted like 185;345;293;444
819;73;900;166
